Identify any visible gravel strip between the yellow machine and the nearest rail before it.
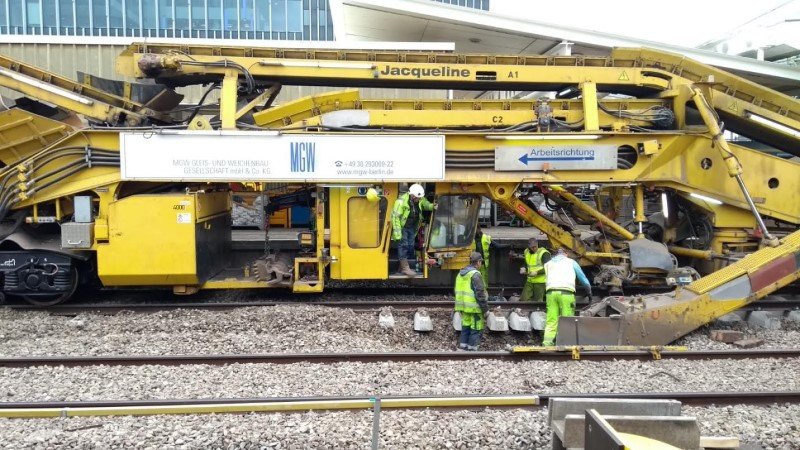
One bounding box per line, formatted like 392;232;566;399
0;305;800;357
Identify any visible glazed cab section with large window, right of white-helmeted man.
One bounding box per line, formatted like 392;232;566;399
426;194;481;269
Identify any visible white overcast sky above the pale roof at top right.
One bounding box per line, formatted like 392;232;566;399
491;0;800;47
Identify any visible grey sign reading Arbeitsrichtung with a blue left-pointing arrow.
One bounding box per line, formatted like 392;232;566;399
494;145;617;171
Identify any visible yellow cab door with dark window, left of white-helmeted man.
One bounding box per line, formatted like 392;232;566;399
329;184;397;280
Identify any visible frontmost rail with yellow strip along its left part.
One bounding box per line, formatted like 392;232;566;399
0;391;800;417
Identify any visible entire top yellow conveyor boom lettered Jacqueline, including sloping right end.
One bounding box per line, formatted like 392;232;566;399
117;43;800;153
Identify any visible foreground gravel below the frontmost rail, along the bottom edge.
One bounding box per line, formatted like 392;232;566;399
0;406;800;450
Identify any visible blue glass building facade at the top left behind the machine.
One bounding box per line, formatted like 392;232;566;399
0;0;333;41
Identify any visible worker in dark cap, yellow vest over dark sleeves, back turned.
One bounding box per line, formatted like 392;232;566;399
455;252;489;351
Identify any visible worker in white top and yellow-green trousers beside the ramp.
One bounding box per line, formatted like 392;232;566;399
542;248;592;346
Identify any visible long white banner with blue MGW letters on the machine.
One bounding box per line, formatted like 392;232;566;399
120;131;444;182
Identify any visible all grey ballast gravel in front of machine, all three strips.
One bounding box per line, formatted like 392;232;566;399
0;305;800;449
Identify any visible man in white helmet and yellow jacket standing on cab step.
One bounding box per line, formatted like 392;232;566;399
392;183;434;277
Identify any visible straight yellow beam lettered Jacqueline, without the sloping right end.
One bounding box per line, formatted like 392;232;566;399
117;44;673;90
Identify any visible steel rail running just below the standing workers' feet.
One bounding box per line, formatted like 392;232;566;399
0;347;800;368
